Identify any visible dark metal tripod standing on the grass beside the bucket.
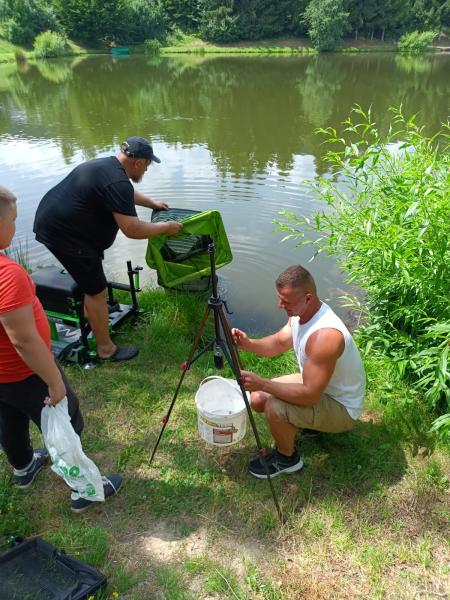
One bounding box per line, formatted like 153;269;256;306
149;242;283;521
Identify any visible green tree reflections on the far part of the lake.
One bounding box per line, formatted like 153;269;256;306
0;55;449;168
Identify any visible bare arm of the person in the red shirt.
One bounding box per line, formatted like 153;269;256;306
0;304;66;404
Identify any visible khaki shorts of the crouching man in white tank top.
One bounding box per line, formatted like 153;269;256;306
270;373;356;433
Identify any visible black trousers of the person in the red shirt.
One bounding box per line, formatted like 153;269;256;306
0;365;84;469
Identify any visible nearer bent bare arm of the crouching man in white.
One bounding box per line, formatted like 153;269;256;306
241;328;344;406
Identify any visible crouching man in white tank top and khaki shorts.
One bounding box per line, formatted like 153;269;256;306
232;266;366;479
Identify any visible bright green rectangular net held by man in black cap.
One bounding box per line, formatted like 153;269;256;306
145;208;233;288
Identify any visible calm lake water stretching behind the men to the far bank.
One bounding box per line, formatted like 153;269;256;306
0;54;450;332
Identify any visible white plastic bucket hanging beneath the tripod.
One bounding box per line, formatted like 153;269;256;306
195;375;249;446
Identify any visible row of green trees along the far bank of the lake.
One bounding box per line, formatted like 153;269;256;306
0;0;450;50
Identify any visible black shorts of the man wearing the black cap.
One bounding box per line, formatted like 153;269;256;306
49;248;107;296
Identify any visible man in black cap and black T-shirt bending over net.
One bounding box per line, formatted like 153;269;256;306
33;137;182;361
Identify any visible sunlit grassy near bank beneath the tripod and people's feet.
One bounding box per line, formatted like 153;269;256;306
0;291;450;600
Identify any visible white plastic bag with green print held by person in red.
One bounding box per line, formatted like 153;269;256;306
41;397;105;502
